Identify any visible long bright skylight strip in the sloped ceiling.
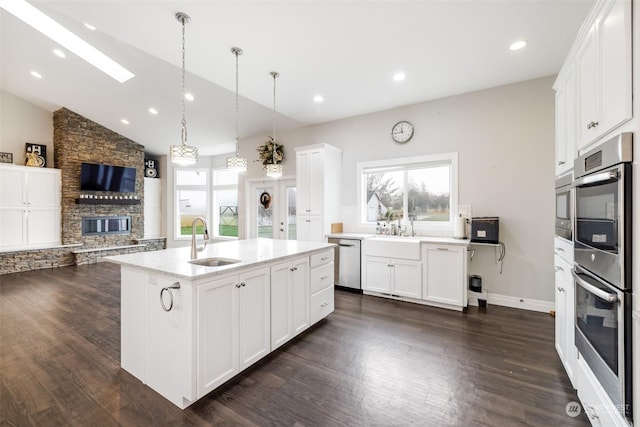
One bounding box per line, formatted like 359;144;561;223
0;0;133;83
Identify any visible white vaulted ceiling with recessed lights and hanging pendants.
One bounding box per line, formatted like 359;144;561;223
0;0;593;155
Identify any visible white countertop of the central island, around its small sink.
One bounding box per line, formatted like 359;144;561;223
103;238;335;280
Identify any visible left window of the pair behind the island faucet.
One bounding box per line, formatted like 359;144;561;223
175;169;209;238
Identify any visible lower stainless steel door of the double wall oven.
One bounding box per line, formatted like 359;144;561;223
572;265;632;417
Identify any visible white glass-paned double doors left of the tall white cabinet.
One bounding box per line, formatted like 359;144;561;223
247;178;297;240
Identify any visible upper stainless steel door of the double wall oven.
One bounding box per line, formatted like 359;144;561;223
574;163;631;289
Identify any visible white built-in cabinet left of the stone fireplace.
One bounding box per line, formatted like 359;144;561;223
0;166;61;247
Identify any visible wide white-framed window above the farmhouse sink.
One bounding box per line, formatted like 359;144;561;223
358;153;458;230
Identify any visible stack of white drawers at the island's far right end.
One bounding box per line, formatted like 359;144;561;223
309;249;335;325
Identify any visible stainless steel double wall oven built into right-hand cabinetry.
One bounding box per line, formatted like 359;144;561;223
573;133;633;419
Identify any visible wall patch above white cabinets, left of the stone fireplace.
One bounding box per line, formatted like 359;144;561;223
0;90;53;167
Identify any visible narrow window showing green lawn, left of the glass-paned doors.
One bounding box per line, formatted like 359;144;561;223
209;169;238;237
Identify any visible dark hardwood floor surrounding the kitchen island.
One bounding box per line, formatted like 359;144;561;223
0;263;589;427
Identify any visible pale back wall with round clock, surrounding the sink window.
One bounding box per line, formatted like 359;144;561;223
239;76;555;301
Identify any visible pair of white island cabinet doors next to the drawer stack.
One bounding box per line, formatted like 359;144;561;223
271;257;309;350
